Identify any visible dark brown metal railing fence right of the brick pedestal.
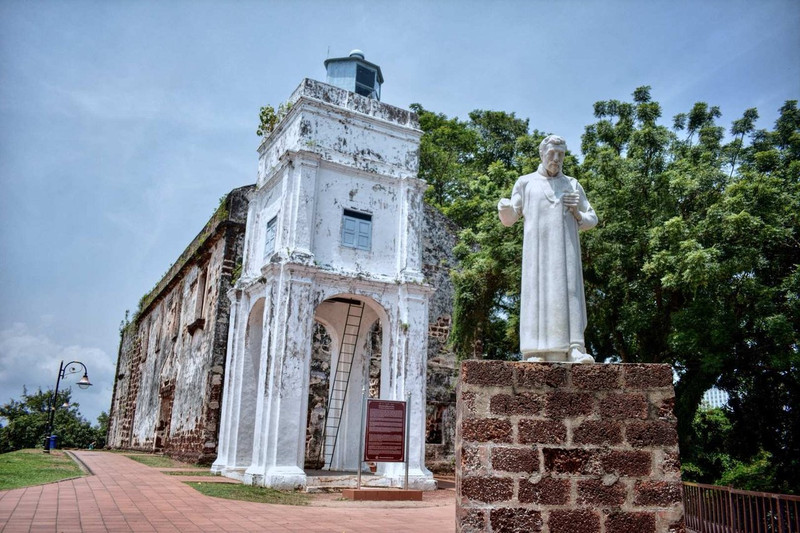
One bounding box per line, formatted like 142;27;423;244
683;482;800;533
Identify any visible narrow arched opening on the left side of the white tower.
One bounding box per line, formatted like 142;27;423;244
236;298;264;467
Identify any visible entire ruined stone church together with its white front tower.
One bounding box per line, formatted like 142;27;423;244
108;51;455;488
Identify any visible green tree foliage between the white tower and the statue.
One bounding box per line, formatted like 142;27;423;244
411;104;578;359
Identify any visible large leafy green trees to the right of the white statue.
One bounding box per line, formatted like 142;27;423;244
583;93;800;494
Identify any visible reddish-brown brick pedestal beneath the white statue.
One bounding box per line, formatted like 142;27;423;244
456;361;684;533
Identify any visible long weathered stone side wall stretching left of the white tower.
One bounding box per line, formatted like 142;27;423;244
108;187;251;463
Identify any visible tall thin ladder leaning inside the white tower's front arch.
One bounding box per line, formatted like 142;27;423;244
320;298;364;469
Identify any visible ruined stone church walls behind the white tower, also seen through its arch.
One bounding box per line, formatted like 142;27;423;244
108;187;458;472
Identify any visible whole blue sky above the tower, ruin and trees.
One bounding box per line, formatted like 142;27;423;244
0;0;800;421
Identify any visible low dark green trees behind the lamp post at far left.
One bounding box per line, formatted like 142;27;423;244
0;389;108;453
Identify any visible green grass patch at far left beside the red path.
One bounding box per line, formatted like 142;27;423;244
0;450;84;490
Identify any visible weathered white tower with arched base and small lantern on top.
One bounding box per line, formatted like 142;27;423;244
213;51;435;489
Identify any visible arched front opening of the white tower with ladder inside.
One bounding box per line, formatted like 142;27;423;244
305;295;388;471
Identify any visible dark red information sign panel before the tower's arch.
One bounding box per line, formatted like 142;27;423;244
364;400;406;463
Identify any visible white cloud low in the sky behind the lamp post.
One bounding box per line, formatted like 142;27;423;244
0;320;116;424
